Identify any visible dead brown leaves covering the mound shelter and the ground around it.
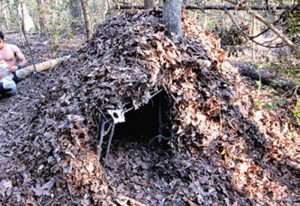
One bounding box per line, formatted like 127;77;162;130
0;10;300;206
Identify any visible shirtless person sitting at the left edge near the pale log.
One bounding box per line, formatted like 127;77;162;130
0;31;27;99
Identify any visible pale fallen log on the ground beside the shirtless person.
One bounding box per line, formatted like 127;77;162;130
16;55;71;79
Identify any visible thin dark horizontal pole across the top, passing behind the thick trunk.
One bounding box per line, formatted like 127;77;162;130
116;4;293;10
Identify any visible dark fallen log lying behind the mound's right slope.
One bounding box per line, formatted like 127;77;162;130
231;62;300;93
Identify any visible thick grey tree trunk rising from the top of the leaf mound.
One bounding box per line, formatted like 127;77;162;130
163;0;182;37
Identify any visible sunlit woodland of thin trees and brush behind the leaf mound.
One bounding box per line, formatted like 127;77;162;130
0;0;300;83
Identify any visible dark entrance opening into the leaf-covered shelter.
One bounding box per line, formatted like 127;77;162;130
113;91;172;147
